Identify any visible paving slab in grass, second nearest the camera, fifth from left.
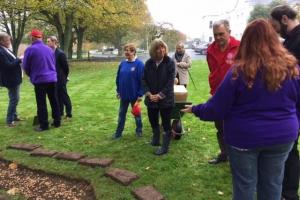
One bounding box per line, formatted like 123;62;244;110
105;168;139;186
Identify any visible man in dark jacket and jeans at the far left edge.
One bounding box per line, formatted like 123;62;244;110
0;33;22;127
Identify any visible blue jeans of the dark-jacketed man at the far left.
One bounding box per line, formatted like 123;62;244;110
6;85;20;124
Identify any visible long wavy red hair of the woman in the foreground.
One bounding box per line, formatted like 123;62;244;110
233;19;299;91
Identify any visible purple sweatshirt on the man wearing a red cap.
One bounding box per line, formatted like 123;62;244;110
23;40;57;84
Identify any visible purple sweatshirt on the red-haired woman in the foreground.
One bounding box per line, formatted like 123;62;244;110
192;70;300;149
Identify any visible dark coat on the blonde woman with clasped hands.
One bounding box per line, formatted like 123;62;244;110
143;56;175;108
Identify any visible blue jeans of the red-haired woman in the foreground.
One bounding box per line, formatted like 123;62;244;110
228;142;294;200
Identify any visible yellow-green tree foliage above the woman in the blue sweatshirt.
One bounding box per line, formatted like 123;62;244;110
89;0;150;54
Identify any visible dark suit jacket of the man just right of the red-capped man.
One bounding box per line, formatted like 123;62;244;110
55;48;69;84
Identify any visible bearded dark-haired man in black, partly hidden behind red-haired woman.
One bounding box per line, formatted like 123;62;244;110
271;5;300;200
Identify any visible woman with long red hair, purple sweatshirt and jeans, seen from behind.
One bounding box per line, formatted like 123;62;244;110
183;19;300;200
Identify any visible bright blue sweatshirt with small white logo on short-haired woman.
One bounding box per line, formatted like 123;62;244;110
116;59;144;101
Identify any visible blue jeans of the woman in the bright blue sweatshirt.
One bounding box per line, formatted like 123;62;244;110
115;100;143;137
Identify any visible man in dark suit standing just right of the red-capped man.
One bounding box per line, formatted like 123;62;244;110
47;36;72;118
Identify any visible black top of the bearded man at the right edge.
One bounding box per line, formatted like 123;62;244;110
283;24;300;64
